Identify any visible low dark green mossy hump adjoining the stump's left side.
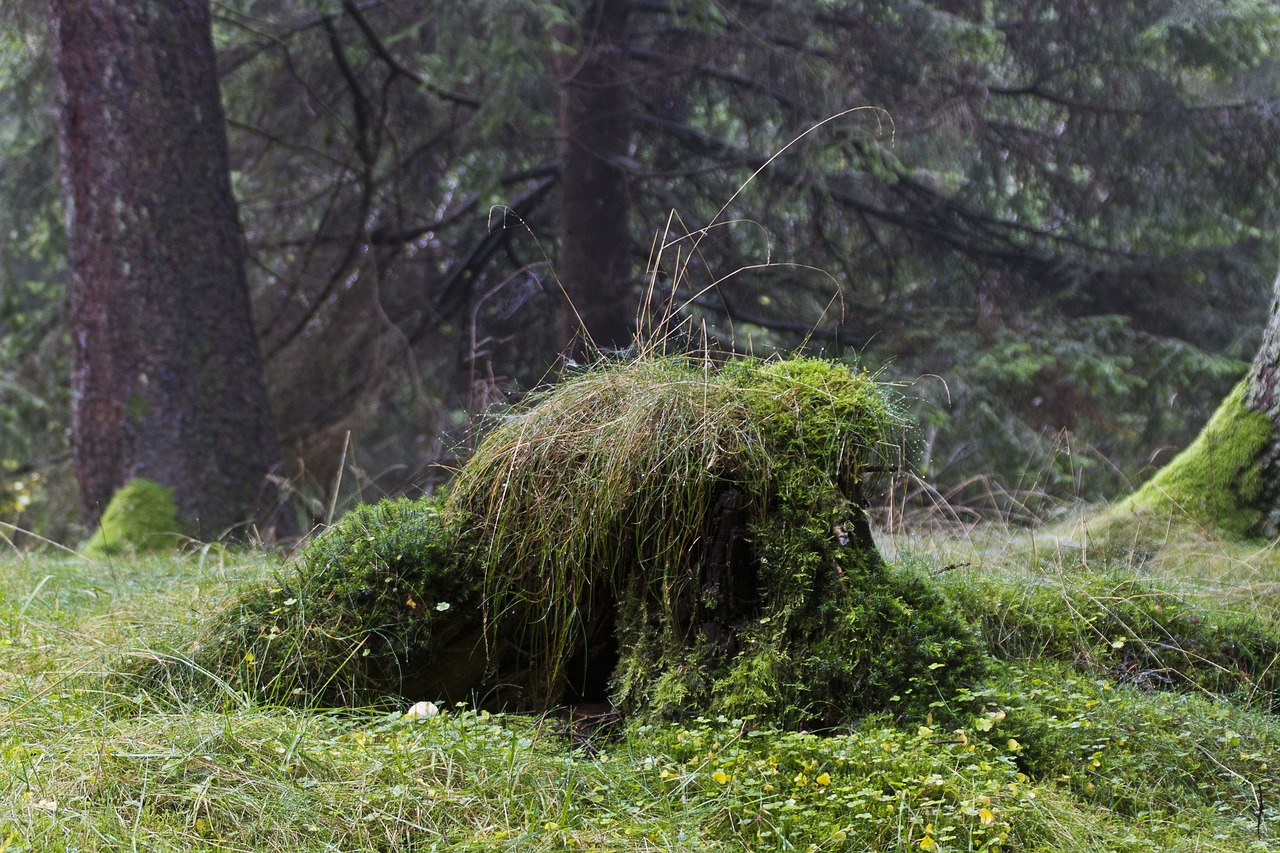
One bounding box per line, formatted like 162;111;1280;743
183;500;483;704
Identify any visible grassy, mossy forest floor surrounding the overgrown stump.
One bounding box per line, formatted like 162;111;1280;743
0;517;1280;853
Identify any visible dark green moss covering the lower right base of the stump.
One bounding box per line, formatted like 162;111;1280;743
614;550;984;727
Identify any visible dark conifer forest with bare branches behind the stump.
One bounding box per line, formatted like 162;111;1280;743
0;0;1280;540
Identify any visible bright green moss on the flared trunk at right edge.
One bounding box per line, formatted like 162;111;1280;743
1111;383;1272;537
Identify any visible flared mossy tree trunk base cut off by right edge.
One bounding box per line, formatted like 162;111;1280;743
1116;268;1280;537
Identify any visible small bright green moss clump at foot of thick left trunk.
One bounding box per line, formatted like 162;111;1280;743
81;479;195;560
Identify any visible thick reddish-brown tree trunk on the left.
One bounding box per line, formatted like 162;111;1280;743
51;0;279;537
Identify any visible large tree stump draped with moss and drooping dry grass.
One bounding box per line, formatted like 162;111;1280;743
447;359;980;725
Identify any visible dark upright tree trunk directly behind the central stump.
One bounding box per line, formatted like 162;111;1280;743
559;0;636;347
